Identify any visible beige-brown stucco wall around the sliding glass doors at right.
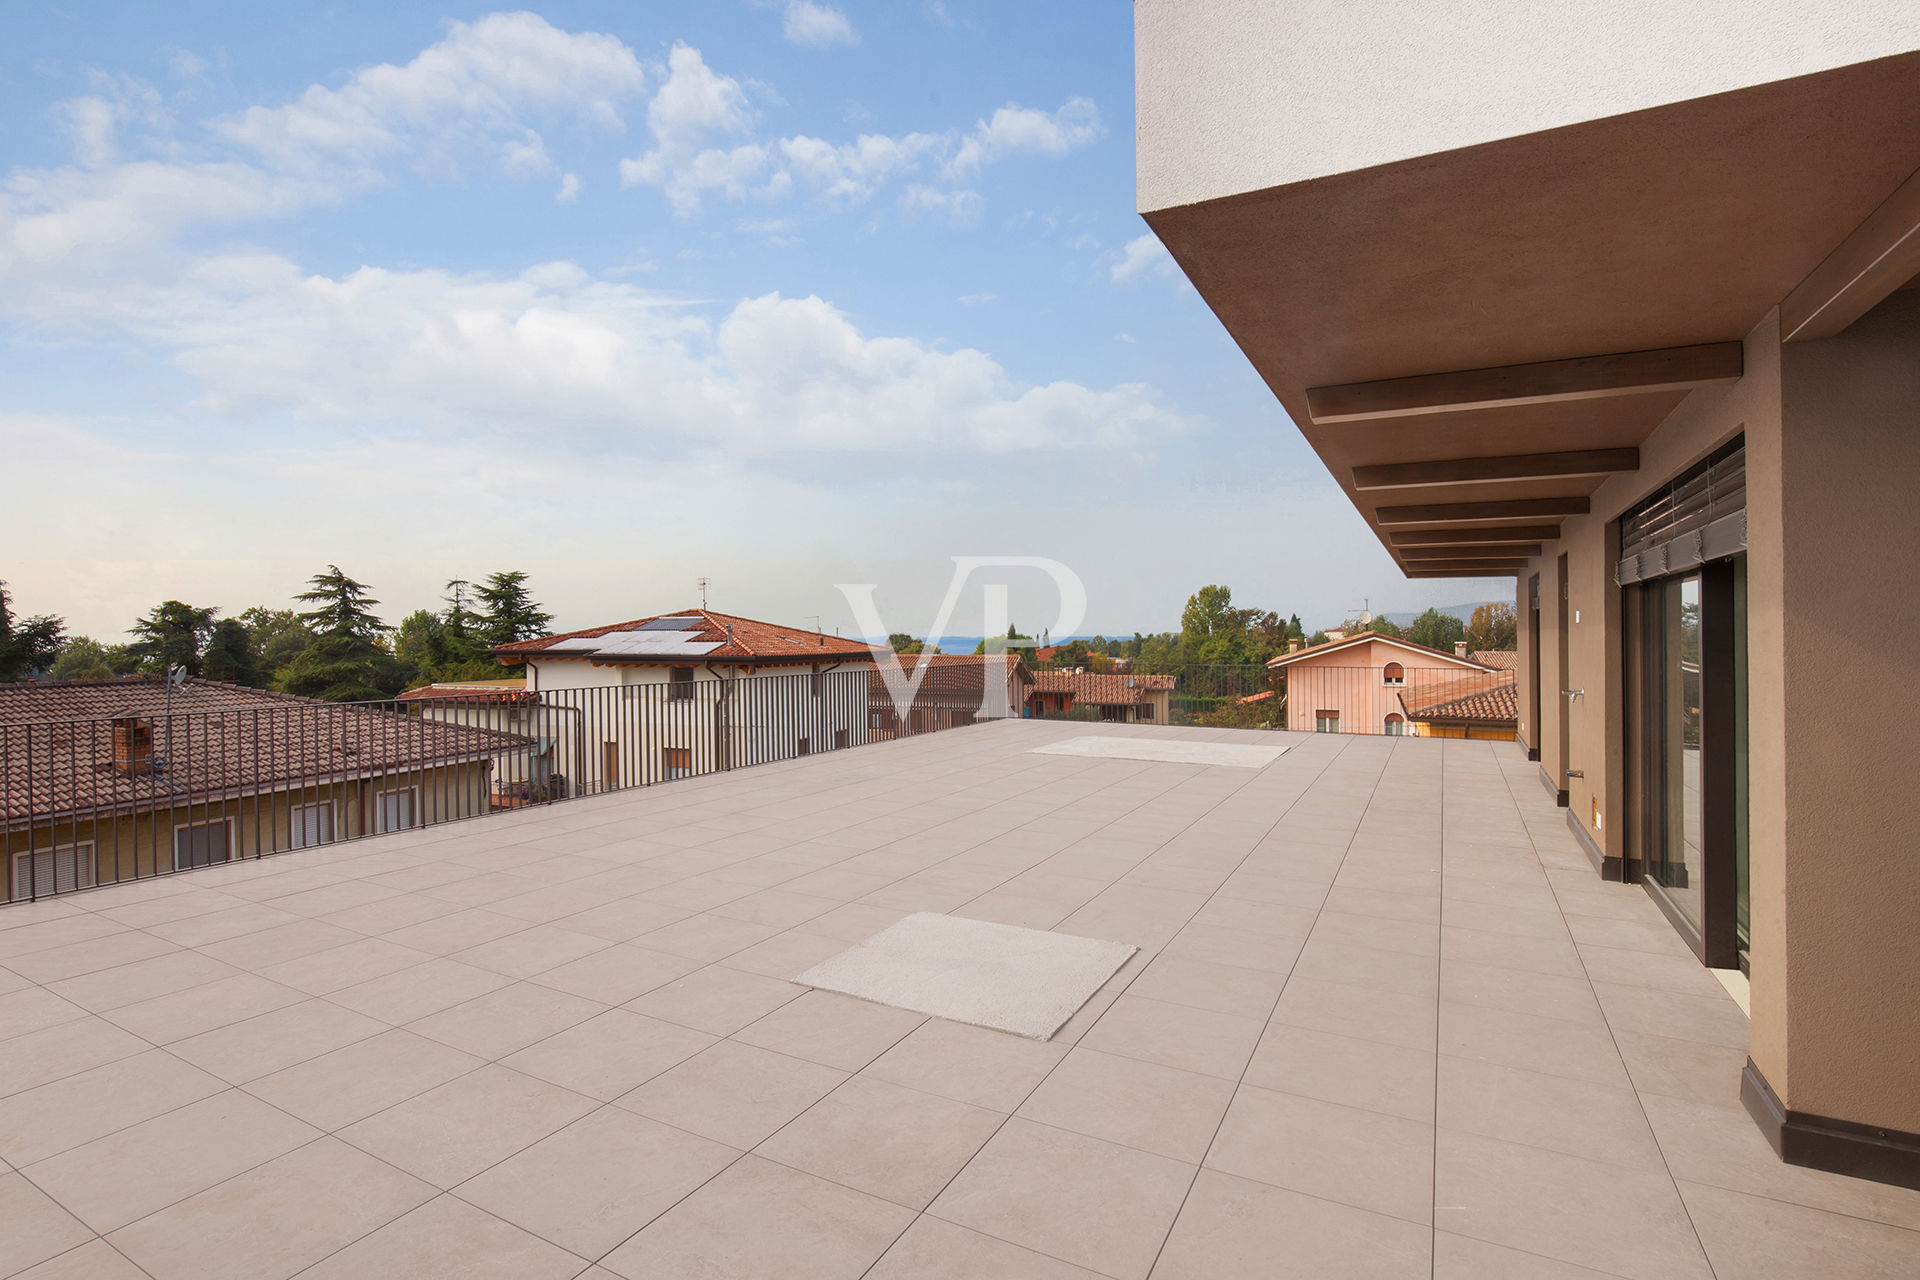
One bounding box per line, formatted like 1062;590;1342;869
1517;290;1920;1132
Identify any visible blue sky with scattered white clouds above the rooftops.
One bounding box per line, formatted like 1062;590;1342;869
0;0;1511;639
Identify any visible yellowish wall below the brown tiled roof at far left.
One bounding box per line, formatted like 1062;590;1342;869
0;762;492;900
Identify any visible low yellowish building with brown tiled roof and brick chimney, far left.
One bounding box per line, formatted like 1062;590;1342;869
0;679;530;898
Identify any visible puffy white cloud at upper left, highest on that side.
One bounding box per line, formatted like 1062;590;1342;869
215;13;647;175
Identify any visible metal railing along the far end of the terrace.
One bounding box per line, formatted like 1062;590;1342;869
1029;662;1517;739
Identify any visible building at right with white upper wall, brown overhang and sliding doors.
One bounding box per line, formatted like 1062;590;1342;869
1135;0;1920;1186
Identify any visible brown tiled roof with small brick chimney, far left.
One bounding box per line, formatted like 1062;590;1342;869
0;679;532;825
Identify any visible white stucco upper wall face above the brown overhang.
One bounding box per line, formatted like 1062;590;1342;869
1135;0;1920;211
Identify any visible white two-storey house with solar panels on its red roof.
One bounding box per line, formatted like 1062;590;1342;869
493;608;876;793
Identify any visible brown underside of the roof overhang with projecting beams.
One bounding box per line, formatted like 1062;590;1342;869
1140;42;1920;576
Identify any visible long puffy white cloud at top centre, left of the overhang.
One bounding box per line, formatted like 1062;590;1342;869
620;44;1100;217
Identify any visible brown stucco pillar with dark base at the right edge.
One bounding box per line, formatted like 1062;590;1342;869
1755;290;1920;1132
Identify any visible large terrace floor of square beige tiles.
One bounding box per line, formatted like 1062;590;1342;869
0;723;1920;1280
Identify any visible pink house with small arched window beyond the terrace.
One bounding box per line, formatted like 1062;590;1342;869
1267;631;1511;735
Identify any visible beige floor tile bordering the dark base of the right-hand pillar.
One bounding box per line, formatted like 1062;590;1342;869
1642;1096;1920;1230
